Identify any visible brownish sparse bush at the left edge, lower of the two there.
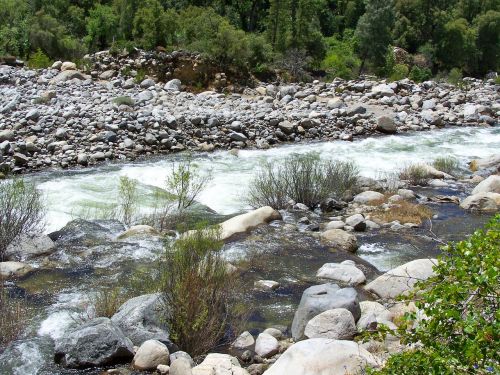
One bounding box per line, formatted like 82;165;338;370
0;277;33;353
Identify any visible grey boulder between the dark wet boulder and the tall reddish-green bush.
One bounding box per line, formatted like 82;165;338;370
111;293;172;349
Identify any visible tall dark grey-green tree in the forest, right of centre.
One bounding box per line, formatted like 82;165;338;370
356;0;394;73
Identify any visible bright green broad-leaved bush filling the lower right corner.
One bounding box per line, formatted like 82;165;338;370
375;215;500;375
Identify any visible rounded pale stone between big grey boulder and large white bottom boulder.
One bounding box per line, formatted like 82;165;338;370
304;308;358;340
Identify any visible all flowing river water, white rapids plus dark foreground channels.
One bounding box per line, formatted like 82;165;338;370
0;127;500;374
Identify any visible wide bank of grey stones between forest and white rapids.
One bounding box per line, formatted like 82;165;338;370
0;56;500;173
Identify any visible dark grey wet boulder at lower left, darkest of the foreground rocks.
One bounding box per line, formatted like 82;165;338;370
54;318;134;368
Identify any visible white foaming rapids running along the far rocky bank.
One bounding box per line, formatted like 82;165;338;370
39;127;500;232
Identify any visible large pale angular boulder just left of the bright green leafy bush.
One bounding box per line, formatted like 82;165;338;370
365;259;437;299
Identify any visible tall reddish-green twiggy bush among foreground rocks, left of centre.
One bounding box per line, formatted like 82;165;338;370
161;228;234;356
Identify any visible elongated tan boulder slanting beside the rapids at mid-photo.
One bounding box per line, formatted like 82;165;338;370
220;206;281;240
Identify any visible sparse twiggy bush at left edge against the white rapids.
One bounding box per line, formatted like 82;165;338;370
0;179;45;261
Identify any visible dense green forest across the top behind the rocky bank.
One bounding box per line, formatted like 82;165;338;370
0;0;500;81
